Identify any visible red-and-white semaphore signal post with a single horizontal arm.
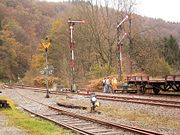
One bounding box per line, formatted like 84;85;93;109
68;19;85;91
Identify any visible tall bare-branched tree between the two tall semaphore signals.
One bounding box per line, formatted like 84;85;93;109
73;0;122;78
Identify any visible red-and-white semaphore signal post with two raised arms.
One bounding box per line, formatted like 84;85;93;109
117;15;128;81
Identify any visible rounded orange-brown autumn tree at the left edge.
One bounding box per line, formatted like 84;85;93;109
0;30;29;80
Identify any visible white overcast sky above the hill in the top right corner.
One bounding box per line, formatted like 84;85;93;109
41;0;180;22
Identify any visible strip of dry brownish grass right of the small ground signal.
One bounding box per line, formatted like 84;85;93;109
99;106;180;129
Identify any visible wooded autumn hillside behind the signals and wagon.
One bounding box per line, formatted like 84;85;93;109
0;0;180;85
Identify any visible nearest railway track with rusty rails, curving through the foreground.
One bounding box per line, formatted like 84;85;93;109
13;90;165;135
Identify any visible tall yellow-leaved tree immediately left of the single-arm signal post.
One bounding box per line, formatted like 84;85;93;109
49;18;70;84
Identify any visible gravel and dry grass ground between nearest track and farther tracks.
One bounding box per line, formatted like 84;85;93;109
0;89;180;135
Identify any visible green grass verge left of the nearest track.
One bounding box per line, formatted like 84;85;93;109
0;97;78;135
